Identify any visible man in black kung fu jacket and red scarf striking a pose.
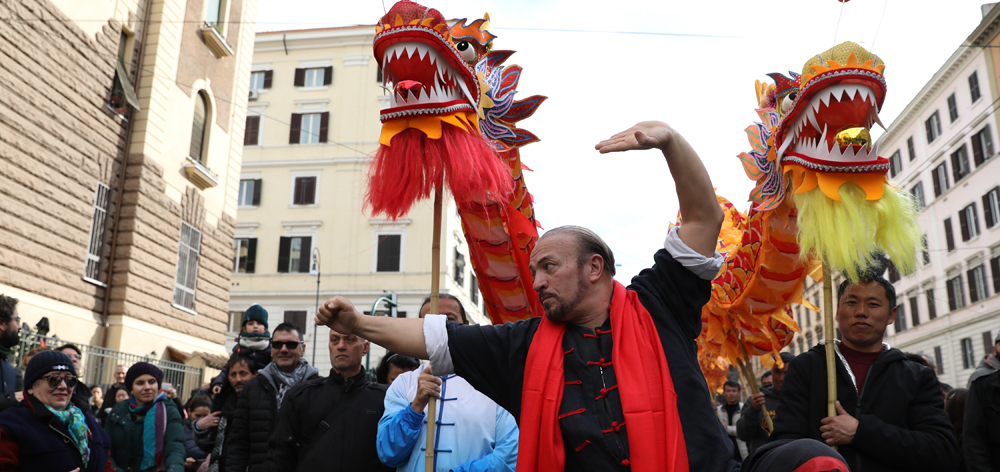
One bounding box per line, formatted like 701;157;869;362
316;122;736;472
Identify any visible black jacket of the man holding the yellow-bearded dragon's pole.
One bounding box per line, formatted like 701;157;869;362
770;345;959;472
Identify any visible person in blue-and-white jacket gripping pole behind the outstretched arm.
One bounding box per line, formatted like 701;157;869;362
377;295;519;472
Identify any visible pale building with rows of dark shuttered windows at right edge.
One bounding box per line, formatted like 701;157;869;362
793;4;1000;387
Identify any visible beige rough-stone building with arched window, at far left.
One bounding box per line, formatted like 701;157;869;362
0;0;256;368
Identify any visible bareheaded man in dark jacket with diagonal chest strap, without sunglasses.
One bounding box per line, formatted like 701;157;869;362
265;330;392;472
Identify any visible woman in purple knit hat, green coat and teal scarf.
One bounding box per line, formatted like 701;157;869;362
104;362;185;472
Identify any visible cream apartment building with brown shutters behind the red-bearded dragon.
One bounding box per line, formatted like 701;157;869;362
229;26;489;373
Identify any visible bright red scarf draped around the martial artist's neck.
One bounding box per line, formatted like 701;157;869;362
517;281;688;472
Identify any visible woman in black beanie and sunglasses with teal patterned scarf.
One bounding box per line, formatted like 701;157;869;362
0;351;111;472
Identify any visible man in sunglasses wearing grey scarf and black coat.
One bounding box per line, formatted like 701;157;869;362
226;323;318;472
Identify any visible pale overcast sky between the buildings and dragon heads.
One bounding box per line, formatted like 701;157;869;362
257;0;983;283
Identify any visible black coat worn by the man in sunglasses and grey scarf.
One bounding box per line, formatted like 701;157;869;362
226;368;318;472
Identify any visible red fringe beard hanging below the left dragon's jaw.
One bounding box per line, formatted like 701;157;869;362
365;123;514;219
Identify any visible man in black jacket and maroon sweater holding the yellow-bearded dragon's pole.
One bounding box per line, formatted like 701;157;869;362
762;268;959;472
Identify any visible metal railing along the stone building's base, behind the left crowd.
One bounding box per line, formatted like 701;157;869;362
13;332;204;402
